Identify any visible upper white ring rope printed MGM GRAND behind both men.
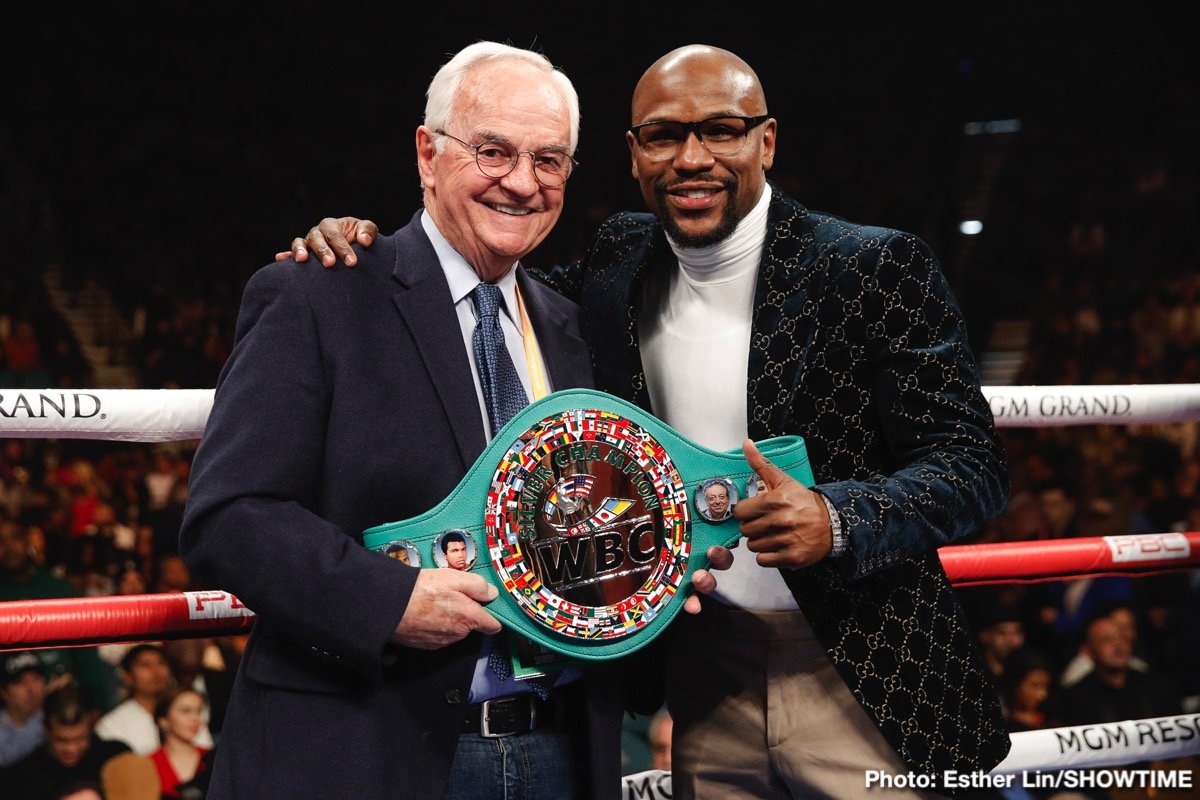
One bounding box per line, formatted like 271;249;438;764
0;384;1200;441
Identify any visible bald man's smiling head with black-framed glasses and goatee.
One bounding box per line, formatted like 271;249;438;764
625;44;775;247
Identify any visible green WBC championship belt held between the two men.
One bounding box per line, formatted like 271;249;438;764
364;389;814;660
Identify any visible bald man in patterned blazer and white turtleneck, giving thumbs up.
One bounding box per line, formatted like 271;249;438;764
283;46;1009;800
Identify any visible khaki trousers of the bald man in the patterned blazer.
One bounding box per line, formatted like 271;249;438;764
667;599;940;800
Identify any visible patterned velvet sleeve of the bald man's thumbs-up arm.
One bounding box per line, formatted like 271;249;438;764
816;233;1009;578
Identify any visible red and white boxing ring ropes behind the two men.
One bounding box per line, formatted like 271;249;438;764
0;384;1200;800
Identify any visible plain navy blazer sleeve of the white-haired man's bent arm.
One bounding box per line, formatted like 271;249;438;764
180;263;418;680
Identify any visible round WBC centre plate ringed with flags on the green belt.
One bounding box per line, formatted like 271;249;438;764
486;409;691;638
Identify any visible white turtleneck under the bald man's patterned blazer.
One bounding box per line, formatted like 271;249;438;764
638;188;797;610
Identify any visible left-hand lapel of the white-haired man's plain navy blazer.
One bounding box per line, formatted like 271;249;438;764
392;212;486;469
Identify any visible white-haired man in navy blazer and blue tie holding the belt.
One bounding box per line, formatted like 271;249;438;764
181;42;710;800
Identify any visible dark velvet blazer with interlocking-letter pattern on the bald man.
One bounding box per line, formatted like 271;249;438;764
544;186;1009;774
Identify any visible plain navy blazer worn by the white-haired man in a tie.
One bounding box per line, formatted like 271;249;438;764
180;213;622;800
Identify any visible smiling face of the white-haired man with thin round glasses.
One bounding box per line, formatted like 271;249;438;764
416;61;571;282
